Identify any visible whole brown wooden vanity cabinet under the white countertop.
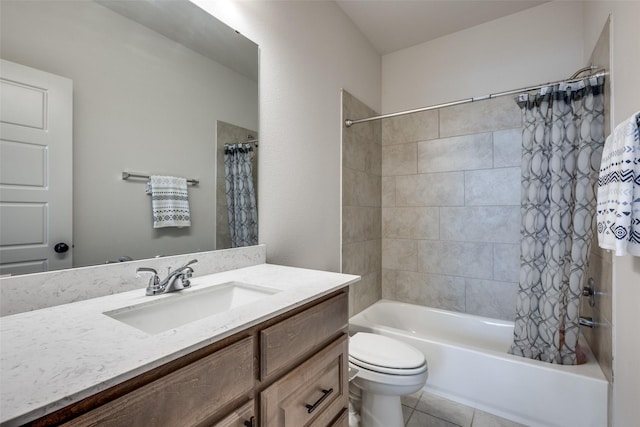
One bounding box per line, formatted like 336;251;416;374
30;289;348;427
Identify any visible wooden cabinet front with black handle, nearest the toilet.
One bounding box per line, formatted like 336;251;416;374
260;334;349;427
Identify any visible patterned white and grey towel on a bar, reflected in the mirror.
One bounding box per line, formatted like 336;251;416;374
149;175;191;228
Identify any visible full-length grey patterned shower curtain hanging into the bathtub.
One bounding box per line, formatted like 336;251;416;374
509;77;604;364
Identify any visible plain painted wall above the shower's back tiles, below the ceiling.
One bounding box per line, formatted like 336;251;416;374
382;1;584;113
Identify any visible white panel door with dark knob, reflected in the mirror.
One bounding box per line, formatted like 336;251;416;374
0;60;73;274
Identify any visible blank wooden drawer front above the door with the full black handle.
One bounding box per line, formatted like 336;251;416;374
260;293;349;381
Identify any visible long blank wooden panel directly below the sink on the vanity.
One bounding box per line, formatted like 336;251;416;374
65;337;254;427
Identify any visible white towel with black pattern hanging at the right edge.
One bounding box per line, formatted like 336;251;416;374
597;112;640;256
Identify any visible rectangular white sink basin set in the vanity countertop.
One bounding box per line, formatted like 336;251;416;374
103;282;280;334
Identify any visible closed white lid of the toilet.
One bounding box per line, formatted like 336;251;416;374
349;332;425;369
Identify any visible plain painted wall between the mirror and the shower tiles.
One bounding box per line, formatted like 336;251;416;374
194;0;381;271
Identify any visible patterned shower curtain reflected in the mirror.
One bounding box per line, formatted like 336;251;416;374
224;144;258;248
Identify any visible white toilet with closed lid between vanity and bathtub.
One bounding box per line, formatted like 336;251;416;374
349;332;428;427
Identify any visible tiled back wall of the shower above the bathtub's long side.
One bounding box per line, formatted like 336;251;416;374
382;97;522;320
